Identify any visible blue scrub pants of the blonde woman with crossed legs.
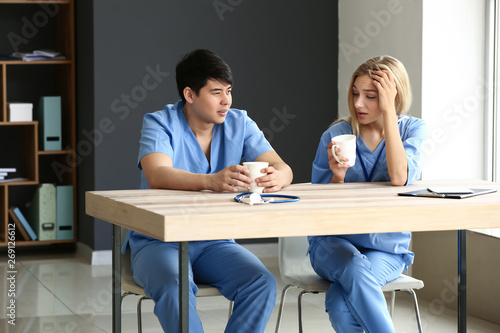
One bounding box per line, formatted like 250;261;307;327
309;236;405;333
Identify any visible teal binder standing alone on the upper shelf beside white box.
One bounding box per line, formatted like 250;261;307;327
38;96;62;150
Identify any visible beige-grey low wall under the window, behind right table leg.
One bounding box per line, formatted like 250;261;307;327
411;231;500;328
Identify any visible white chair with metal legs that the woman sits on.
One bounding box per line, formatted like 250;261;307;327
275;237;424;333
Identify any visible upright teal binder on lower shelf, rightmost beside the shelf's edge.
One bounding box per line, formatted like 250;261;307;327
56;185;74;239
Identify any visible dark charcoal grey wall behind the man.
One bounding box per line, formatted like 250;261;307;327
77;0;338;250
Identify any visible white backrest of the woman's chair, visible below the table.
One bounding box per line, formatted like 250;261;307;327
278;236;316;277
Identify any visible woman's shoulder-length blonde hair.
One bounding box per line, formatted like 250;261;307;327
342;56;412;135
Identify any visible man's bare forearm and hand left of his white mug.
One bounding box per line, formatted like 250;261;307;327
141;153;252;192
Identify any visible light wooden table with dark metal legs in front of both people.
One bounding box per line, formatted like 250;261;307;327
86;180;500;332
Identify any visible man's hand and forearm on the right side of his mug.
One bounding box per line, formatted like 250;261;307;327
255;150;293;193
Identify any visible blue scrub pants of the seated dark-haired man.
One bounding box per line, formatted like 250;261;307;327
129;234;276;333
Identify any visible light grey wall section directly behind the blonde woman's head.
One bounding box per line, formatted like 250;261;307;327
338;0;423;118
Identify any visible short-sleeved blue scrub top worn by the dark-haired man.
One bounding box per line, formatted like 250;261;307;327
122;100;273;253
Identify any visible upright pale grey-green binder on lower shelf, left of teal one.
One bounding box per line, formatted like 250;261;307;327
29;184;56;241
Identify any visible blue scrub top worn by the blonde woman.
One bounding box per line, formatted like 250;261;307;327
309;116;427;266
